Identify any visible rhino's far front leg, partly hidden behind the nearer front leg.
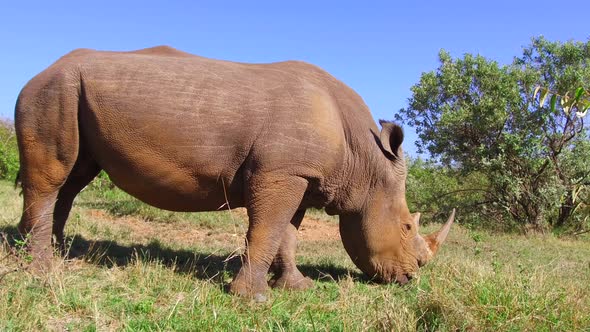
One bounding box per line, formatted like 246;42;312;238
270;210;313;290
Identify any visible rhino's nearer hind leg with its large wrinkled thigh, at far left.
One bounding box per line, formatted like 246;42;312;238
15;74;79;272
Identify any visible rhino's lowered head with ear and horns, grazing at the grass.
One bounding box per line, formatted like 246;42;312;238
340;121;455;284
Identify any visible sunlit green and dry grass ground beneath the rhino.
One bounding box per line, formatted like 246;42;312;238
0;182;590;331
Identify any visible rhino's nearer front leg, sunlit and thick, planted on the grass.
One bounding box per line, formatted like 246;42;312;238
230;175;307;299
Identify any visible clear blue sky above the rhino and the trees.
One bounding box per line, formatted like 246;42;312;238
0;0;590;152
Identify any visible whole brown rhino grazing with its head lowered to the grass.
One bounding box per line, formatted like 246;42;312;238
15;46;454;296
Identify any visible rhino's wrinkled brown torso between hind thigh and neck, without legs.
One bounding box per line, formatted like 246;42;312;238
68;52;364;210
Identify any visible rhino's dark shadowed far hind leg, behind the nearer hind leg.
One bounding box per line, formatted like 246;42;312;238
53;156;100;256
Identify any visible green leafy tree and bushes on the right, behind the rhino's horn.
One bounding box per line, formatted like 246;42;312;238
397;38;590;229
